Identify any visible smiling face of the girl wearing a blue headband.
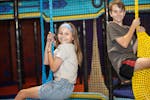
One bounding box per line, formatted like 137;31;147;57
58;27;74;44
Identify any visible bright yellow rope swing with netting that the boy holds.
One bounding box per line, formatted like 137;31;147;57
132;0;150;100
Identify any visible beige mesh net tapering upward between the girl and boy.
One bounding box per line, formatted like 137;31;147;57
89;20;108;96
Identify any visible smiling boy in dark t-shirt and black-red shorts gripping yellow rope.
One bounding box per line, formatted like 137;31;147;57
107;0;150;80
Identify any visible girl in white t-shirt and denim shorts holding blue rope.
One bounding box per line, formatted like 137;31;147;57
15;23;82;100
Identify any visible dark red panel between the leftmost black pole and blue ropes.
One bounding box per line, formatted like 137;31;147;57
21;19;41;77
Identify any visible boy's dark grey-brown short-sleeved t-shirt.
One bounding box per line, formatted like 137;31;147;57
107;22;136;80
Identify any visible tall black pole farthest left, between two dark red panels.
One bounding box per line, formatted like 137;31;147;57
14;0;22;90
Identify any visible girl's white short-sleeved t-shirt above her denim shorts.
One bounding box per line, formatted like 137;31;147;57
54;43;78;83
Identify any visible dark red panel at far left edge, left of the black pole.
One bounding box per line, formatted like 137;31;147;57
0;21;11;84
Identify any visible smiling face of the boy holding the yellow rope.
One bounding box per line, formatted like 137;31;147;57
110;5;126;23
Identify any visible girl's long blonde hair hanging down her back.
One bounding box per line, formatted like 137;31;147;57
56;23;83;66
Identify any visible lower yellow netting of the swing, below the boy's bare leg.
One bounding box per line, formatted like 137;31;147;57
132;68;150;100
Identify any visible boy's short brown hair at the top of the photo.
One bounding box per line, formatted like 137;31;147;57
109;0;125;12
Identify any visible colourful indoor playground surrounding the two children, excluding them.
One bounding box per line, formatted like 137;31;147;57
0;0;150;100
